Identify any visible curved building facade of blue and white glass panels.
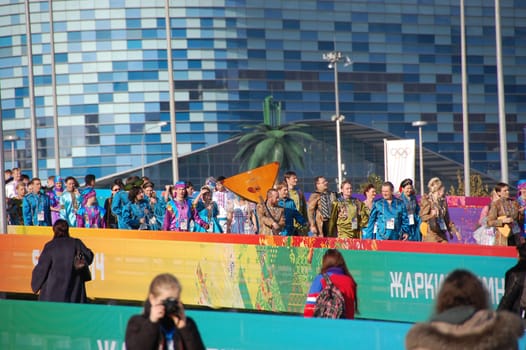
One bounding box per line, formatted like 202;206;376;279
0;0;526;189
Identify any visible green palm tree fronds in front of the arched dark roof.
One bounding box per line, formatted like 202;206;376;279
234;123;315;170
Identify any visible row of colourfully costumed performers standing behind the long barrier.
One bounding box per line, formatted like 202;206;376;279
5;168;526;245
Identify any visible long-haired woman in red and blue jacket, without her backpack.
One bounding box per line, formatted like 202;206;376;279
303;249;358;319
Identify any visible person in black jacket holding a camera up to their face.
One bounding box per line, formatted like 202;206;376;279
125;273;205;350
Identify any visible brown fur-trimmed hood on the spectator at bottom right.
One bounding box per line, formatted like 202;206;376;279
406;307;524;350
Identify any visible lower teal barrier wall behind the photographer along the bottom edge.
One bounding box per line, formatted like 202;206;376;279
0;300;416;350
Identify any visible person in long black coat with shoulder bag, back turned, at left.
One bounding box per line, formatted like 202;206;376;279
31;219;93;303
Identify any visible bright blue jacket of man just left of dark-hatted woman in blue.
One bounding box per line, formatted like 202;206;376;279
362;197;410;240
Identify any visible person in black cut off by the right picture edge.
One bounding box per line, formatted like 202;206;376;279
498;243;526;318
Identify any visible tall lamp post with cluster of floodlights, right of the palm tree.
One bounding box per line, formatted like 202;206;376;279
322;51;352;190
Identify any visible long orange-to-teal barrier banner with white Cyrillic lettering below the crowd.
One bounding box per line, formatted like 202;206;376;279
0;226;516;322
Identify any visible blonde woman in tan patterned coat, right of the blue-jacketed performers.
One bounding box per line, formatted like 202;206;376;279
420;177;462;243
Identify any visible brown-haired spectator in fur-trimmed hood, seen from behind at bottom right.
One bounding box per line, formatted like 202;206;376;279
405;270;523;350
